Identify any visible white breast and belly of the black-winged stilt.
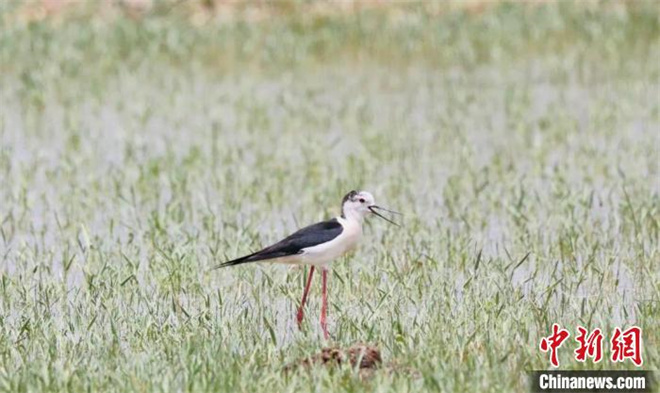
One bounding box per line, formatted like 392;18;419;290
302;217;362;266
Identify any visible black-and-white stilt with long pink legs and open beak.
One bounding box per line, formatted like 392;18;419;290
211;190;401;340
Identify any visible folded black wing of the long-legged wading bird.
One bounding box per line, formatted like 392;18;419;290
213;218;344;269
